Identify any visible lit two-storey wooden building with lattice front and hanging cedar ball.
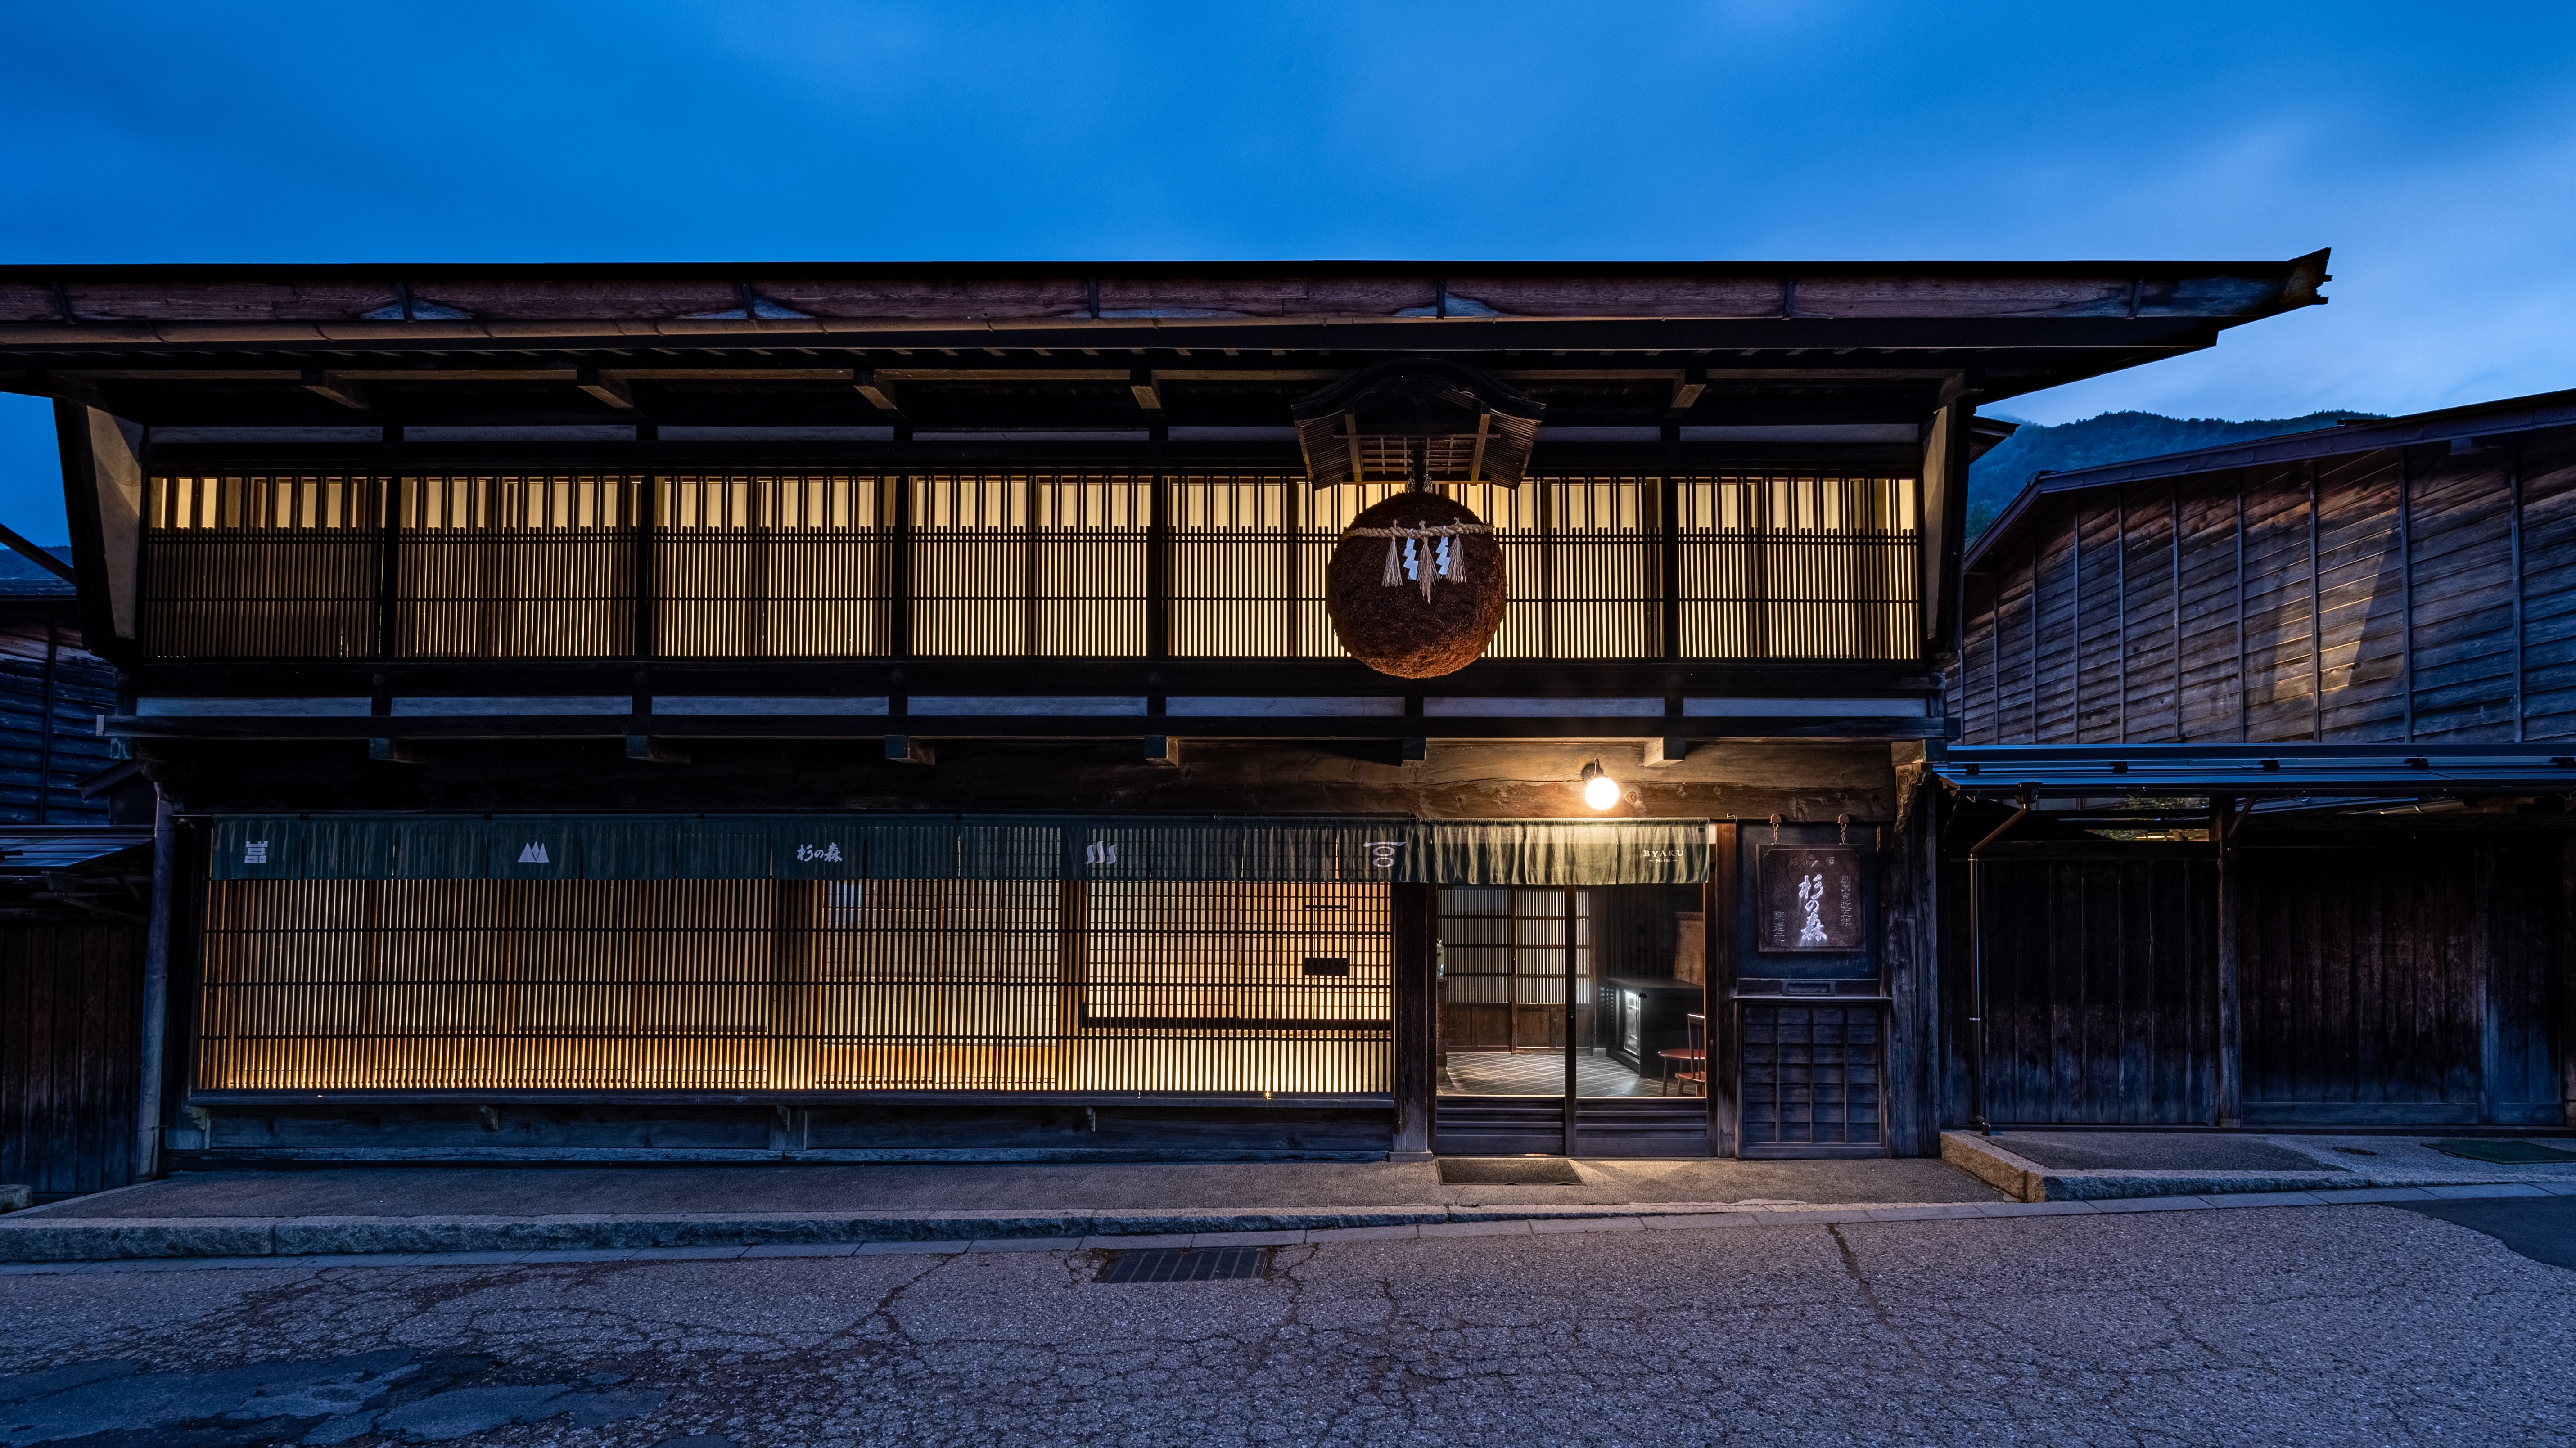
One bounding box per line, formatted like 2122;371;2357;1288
0;252;2323;1162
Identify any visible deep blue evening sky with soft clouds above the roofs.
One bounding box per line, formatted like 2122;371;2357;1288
0;0;2576;541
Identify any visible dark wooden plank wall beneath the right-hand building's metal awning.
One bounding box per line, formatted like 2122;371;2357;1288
1945;837;2571;1126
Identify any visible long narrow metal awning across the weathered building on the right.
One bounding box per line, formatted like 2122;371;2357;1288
1930;739;2576;799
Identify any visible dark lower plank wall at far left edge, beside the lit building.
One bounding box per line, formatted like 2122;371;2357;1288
0;922;144;1196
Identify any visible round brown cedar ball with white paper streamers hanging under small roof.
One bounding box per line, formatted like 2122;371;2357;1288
1324;492;1512;678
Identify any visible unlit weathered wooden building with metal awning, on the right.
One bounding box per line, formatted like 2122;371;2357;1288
1935;391;2576;1129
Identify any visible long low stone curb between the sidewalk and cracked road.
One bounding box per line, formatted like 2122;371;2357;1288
20;1180;2576;1273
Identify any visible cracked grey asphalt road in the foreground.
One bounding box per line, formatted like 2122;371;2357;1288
0;1203;2576;1448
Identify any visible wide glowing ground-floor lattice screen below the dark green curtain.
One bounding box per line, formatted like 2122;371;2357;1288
196;879;1394;1093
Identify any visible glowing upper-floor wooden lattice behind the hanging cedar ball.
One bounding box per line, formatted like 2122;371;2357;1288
142;472;1922;662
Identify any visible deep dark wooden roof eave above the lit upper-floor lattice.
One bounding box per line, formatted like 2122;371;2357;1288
0;252;2326;430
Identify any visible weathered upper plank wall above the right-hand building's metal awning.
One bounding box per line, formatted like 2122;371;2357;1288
1953;427;2576;745
